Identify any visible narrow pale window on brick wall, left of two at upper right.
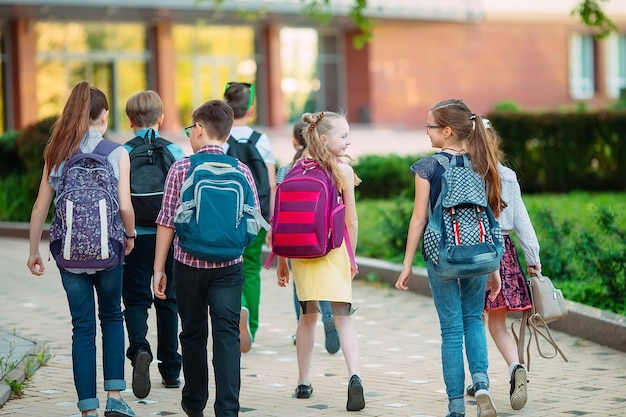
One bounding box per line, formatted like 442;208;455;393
570;33;596;100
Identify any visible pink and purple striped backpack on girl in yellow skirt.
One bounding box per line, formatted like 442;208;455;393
265;158;357;271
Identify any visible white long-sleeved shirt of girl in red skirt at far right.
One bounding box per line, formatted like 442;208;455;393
498;164;540;265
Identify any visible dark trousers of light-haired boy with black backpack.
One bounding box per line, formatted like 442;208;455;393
122;235;181;380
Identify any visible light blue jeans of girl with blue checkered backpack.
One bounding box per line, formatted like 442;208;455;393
426;262;489;413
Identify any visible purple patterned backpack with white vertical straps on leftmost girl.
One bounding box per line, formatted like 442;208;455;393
50;139;124;270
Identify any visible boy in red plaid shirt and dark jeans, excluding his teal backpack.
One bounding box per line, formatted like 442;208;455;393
153;100;259;417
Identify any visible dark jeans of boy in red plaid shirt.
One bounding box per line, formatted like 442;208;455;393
174;261;244;417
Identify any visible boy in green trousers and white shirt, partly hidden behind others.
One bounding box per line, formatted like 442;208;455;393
224;82;276;352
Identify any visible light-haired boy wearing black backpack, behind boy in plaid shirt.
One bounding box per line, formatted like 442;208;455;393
122;90;185;398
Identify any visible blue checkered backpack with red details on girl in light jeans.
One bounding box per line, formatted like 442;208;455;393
422;154;504;278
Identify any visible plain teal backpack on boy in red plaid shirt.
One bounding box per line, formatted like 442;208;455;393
174;153;270;262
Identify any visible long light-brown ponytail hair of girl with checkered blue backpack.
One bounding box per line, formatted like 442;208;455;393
430;99;504;217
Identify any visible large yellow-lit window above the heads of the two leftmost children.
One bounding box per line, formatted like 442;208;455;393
36;22;150;131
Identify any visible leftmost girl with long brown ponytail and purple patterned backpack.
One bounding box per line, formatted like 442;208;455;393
27;81;136;417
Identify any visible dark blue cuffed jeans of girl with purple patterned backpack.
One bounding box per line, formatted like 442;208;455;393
60;264;126;411
